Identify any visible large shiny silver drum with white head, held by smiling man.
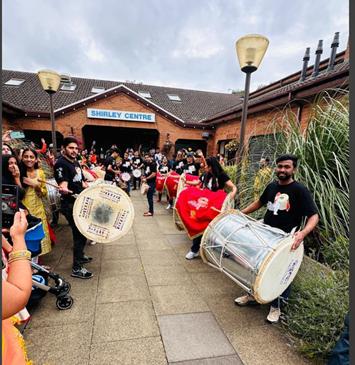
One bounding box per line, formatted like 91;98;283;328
200;210;304;304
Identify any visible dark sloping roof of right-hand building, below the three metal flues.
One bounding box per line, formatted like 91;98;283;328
201;61;350;125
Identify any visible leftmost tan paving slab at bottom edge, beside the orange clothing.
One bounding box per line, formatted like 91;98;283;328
24;321;92;365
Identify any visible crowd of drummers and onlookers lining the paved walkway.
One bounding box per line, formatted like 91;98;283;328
2;133;326;364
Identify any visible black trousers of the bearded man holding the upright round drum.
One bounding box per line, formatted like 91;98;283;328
61;200;86;270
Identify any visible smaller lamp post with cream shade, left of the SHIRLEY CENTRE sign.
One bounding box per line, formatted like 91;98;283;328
37;70;60;158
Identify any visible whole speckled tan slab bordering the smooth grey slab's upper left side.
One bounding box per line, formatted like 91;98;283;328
93;301;159;343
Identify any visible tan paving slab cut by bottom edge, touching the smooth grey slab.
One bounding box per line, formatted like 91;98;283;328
89;337;167;365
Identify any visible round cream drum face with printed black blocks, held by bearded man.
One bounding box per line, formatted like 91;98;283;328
73;183;134;243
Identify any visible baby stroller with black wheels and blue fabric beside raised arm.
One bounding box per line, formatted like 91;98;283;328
25;216;74;310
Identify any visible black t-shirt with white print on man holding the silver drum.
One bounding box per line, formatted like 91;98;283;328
260;181;318;232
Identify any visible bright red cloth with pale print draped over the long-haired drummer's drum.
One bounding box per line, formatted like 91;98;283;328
175;186;227;238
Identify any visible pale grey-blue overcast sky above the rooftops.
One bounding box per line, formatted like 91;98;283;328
2;0;349;93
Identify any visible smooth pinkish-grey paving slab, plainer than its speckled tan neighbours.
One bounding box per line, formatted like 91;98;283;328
158;312;235;362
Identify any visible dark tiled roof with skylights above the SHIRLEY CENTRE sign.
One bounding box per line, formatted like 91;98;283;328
2;70;240;123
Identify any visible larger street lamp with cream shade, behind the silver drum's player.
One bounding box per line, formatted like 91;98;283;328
235;34;269;164
